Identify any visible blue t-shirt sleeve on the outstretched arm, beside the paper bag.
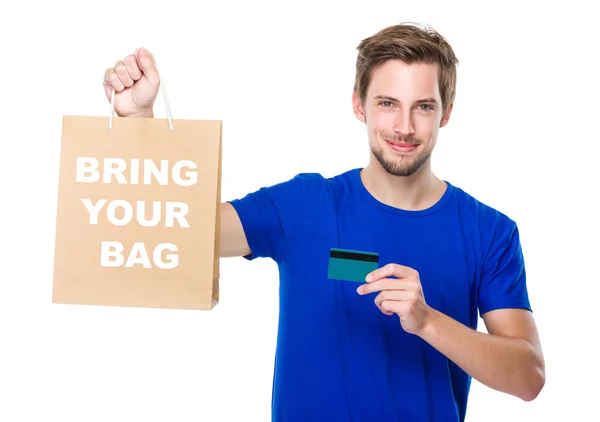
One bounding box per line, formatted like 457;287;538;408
228;173;324;262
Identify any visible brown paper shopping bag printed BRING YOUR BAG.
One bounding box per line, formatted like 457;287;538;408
52;116;222;310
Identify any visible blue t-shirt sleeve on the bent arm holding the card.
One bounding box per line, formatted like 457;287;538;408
477;215;531;315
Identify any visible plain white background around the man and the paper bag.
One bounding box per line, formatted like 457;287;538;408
0;1;600;422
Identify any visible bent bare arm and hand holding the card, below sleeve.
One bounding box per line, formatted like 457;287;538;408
358;264;545;401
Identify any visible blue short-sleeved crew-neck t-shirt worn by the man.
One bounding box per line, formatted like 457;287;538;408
230;169;531;422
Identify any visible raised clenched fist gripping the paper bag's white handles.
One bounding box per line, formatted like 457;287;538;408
104;48;160;117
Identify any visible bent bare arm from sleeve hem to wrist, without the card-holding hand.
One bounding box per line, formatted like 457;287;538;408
415;309;545;401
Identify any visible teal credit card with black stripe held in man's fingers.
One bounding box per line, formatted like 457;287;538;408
327;248;379;283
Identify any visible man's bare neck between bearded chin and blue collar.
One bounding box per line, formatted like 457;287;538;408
360;160;447;211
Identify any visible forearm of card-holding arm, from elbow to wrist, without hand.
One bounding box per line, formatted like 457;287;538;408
418;310;544;401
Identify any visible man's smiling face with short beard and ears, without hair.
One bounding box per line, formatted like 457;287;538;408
353;60;452;176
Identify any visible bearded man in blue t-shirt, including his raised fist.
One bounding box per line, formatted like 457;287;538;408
104;25;545;422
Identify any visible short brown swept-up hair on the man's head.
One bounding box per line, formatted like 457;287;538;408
354;23;458;110
